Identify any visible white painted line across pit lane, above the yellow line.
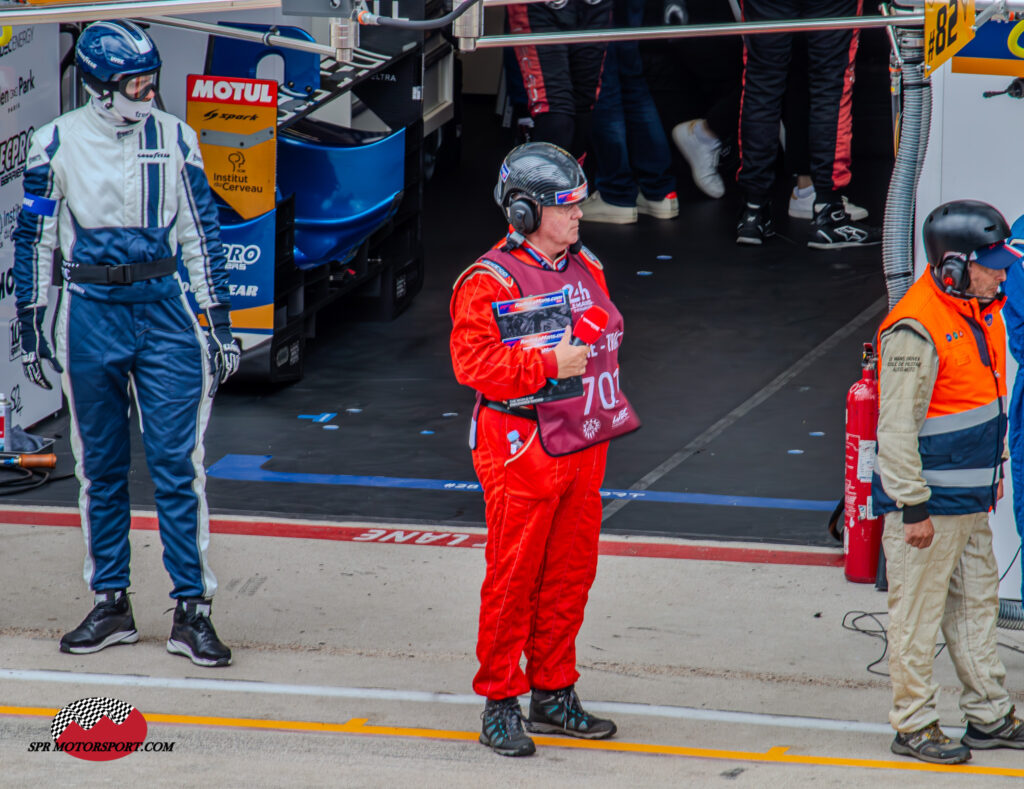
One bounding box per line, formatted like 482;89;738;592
0;668;933;737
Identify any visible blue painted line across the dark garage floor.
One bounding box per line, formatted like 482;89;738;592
206;454;836;513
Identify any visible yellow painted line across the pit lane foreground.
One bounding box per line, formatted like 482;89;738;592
8;706;1024;778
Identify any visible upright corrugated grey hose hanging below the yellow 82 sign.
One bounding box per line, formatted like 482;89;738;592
882;57;932;309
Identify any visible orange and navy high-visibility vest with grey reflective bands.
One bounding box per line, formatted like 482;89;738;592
871;271;1007;515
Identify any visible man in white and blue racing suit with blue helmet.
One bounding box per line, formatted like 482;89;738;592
14;20;241;666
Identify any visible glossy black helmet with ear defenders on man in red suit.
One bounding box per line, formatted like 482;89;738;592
495;142;587;233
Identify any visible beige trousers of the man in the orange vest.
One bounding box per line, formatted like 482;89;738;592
882;512;1011;733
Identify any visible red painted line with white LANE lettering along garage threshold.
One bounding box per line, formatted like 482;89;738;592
0;510;843;567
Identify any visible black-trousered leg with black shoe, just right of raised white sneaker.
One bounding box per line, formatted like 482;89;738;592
736;0;799;245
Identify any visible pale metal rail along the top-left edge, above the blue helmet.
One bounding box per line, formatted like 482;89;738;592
0;0;281;25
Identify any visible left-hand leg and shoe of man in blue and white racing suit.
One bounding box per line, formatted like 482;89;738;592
56;296;138;654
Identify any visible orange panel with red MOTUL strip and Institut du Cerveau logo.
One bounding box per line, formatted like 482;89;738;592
186;74;278;219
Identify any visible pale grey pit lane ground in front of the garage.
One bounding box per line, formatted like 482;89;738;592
0;517;1024;787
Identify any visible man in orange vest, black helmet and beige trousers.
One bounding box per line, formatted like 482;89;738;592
872;201;1024;764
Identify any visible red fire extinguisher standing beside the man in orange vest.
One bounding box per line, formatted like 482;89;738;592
843;343;883;583
